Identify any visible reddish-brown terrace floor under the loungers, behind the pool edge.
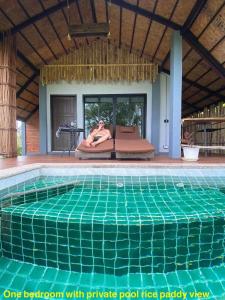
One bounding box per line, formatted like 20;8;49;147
0;154;225;170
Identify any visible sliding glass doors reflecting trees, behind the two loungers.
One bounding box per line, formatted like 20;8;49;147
84;95;146;137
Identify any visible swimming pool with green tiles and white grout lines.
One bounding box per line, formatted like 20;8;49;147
0;168;225;299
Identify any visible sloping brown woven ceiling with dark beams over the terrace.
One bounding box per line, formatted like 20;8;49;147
0;0;225;121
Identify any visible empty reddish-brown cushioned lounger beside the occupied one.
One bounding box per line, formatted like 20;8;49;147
115;126;155;159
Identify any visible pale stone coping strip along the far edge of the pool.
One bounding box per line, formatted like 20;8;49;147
0;162;225;179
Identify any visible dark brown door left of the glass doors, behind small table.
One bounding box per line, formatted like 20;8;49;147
51;95;77;151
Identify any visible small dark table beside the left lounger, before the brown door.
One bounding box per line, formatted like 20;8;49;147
56;126;84;156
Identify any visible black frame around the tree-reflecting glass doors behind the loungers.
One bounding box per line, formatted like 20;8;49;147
83;93;147;138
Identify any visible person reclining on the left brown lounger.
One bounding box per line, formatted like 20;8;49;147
83;120;112;147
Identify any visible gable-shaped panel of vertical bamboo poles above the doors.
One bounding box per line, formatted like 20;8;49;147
40;40;158;84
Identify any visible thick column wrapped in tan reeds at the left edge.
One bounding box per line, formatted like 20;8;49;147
0;35;17;157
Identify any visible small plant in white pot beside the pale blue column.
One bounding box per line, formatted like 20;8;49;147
182;131;199;161
